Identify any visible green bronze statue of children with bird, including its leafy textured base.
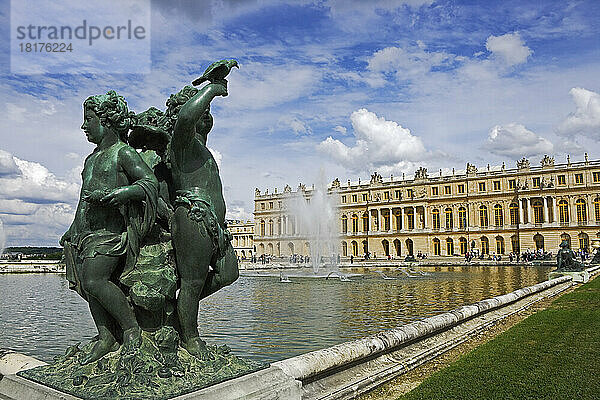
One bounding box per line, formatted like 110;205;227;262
19;60;264;399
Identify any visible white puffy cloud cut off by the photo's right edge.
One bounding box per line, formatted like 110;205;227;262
557;87;600;140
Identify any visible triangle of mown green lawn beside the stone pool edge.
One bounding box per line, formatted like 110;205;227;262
400;278;600;400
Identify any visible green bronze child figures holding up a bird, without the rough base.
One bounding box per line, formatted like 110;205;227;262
60;60;238;365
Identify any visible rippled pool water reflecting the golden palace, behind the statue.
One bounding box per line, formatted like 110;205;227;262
0;267;549;362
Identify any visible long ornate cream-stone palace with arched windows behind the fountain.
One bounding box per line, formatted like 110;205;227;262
254;154;600;257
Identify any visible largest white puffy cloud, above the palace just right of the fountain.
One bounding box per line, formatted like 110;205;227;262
317;108;428;174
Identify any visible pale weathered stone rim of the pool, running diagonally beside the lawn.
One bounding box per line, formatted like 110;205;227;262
0;266;600;400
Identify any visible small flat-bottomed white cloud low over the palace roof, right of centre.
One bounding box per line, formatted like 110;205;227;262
487;123;554;158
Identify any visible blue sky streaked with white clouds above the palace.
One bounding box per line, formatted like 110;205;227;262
0;0;600;245
